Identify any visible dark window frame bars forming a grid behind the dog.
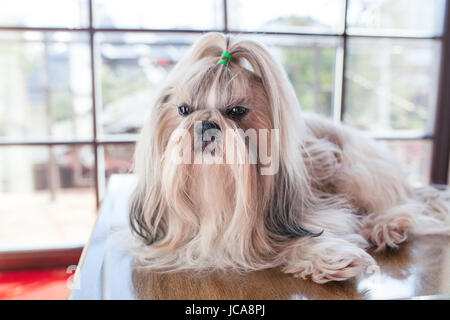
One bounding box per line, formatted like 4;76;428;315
0;0;450;267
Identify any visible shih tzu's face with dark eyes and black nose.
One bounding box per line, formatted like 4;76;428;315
157;65;273;165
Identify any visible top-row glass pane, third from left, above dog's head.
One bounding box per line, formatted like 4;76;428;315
228;0;344;33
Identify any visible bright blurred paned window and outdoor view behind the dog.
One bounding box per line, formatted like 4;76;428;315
0;0;450;298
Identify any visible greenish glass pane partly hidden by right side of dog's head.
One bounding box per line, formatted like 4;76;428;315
253;36;339;117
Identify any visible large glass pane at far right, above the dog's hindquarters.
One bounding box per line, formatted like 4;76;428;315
344;39;440;136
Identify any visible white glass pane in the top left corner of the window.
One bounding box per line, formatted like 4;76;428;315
0;0;89;28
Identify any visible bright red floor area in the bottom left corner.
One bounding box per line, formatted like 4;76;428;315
0;268;73;300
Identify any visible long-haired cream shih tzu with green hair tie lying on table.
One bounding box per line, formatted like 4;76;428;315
130;33;450;283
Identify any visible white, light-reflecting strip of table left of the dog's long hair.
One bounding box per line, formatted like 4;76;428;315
69;174;136;300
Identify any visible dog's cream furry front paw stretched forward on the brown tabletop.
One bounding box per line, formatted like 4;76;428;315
282;247;378;283
